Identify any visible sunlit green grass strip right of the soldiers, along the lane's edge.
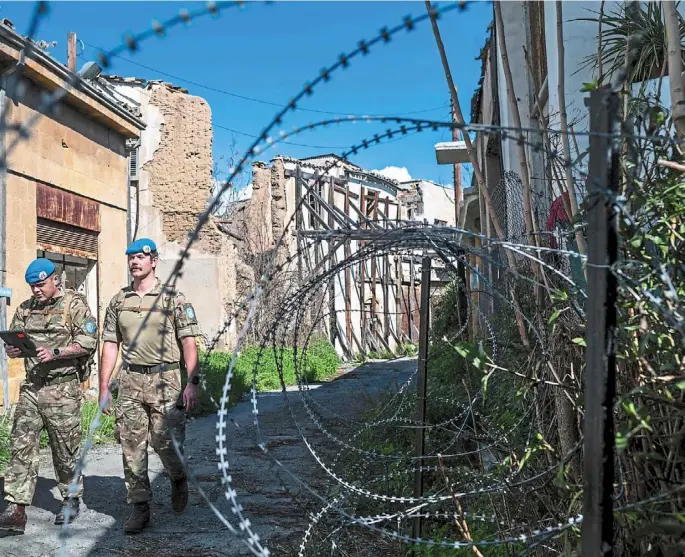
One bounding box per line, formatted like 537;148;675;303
193;338;340;415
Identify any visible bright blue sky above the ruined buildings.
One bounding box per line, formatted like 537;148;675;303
0;1;492;184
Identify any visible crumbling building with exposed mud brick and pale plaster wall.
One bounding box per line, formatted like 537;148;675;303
103;76;236;348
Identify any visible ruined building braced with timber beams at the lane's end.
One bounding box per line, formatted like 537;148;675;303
222;155;455;357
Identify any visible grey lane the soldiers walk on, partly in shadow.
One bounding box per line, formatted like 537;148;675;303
0;359;416;557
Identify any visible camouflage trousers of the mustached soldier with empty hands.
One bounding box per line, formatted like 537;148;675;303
115;370;186;504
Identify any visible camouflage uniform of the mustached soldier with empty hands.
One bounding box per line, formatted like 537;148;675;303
102;279;199;504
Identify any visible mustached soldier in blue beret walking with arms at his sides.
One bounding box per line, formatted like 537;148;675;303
100;239;199;534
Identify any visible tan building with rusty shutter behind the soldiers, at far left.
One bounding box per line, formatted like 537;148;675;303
0;20;145;404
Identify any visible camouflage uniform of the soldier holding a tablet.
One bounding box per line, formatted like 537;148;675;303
5;290;97;505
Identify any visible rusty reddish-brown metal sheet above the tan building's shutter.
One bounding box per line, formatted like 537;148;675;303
36;184;100;232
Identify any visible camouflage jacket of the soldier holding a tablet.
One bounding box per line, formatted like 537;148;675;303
10;289;97;381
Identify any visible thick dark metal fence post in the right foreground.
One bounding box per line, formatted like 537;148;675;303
581;87;618;557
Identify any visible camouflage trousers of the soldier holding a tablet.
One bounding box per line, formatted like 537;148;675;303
5;380;83;505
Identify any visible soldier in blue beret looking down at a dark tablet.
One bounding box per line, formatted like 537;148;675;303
0;258;97;534
